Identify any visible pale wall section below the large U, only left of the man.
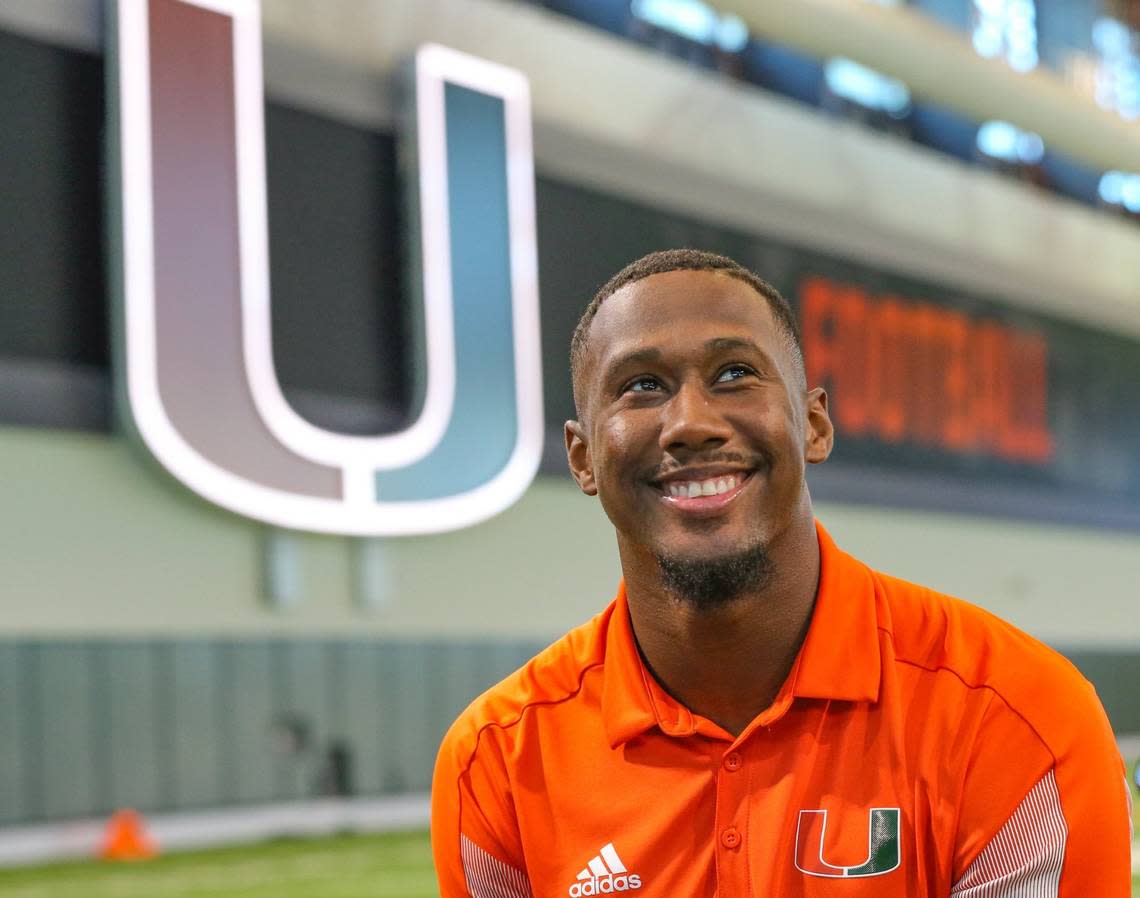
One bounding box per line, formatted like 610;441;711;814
0;430;617;638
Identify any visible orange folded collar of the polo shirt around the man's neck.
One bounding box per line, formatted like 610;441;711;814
602;522;881;748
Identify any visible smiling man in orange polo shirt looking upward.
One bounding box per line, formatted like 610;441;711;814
432;250;1130;898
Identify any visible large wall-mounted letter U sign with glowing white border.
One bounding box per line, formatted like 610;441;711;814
108;0;543;536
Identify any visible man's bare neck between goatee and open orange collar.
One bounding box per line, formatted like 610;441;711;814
622;517;820;736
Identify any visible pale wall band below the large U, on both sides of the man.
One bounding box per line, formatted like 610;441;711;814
0;430;1140;646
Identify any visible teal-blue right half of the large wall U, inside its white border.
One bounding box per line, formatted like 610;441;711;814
376;84;519;501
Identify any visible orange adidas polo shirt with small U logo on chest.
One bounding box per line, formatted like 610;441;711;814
432;528;1130;898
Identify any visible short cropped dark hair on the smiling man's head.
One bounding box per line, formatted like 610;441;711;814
570;250;806;418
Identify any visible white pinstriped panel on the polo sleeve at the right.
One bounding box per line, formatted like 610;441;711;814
950;770;1068;898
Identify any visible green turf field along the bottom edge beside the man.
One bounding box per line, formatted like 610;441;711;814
0;833;1140;898
